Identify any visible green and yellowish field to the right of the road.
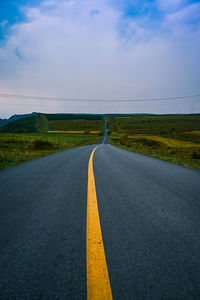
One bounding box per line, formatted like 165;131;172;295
108;115;200;169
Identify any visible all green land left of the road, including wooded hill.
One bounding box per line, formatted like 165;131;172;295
0;113;104;169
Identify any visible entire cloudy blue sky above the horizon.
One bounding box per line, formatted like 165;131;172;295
0;0;200;118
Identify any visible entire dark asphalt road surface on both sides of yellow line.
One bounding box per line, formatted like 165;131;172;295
0;127;200;300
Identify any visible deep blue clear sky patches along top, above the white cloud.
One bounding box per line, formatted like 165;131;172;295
0;0;200;40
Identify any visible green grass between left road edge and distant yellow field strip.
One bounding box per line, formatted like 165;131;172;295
0;133;100;170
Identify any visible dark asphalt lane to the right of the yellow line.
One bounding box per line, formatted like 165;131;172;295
94;145;200;300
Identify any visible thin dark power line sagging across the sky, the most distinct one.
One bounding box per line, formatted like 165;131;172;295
0;93;200;102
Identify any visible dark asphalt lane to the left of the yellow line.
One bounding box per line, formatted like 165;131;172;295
0;146;93;300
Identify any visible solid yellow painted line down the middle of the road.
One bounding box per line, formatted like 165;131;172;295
86;146;113;300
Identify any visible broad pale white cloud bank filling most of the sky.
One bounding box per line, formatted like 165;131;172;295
0;0;200;113
